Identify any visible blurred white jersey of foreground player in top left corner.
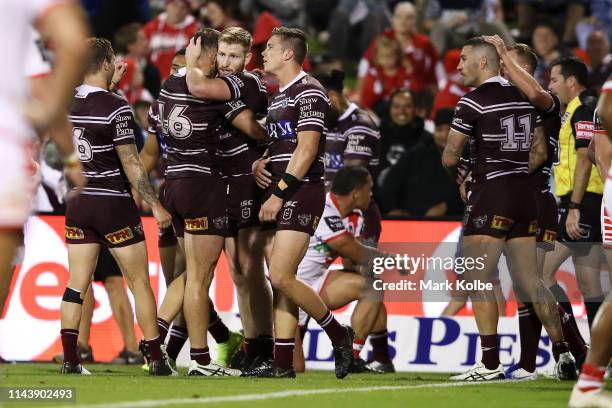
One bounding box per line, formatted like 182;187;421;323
0;0;66;141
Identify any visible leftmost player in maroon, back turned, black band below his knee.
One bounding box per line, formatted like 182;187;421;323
61;39;176;375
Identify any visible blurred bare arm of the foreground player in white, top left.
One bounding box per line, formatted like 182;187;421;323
26;2;89;130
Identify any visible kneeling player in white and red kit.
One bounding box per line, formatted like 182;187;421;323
296;166;395;373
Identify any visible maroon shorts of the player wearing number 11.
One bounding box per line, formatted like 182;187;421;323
463;177;538;239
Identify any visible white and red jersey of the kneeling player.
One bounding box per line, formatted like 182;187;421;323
297;193;364;283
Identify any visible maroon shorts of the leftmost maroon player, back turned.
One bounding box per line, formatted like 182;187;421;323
66;193;145;248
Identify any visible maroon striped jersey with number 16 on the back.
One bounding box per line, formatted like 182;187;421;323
158;68;244;179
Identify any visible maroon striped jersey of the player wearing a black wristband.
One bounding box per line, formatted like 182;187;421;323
266;71;330;183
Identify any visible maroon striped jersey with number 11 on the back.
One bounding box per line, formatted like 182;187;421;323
451;76;542;183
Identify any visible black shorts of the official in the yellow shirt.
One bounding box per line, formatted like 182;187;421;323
557;191;603;243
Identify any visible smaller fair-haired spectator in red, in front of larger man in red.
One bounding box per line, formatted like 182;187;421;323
361;37;411;116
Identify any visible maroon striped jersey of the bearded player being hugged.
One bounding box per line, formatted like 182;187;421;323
218;71;268;177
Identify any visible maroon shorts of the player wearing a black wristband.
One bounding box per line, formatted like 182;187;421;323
262;183;325;236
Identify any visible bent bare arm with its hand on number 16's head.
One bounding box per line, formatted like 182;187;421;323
185;37;232;101
